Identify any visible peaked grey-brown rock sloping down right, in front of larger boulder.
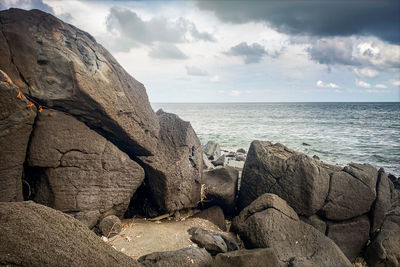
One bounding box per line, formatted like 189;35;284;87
232;194;352;266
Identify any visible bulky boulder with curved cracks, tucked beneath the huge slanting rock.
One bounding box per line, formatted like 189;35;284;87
26;110;144;225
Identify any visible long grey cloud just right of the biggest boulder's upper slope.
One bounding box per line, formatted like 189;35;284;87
106;7;215;50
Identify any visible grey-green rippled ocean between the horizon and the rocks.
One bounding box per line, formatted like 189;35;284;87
152;102;400;176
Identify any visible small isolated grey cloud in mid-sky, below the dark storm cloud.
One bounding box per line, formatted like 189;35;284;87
225;42;268;64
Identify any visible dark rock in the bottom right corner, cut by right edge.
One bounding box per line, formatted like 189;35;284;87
364;204;400;267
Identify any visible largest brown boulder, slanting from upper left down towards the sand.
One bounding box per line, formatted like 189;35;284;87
0;9;202;215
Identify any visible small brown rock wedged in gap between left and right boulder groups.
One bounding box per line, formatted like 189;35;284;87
203;167;239;214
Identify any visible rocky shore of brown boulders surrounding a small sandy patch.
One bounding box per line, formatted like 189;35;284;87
0;9;400;267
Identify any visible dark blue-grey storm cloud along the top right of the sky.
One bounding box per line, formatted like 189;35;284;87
197;0;400;43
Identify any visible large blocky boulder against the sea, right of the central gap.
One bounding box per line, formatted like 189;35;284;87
238;141;329;216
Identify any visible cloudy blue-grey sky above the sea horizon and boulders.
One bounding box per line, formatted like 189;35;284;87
0;0;400;102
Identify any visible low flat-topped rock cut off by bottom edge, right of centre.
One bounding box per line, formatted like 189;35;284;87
212;248;282;267
